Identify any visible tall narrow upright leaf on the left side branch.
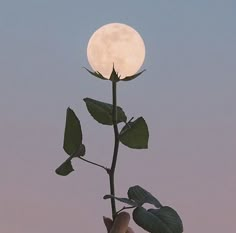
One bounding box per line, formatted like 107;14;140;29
63;108;82;155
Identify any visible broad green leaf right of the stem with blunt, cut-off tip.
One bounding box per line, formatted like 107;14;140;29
119;117;149;149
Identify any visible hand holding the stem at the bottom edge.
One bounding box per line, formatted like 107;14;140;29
103;212;134;233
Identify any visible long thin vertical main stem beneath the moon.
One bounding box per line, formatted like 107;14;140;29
109;81;119;220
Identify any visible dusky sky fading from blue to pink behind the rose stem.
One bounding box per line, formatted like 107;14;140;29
0;0;236;233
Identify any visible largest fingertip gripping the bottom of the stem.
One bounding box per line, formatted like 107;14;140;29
110;212;130;233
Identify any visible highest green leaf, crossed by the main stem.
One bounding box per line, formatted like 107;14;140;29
84;98;127;125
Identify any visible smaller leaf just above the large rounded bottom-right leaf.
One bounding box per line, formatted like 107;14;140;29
128;185;162;208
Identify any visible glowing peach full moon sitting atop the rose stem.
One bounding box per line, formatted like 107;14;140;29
87;23;145;79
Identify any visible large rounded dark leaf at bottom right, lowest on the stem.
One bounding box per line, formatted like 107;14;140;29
133;207;183;233
